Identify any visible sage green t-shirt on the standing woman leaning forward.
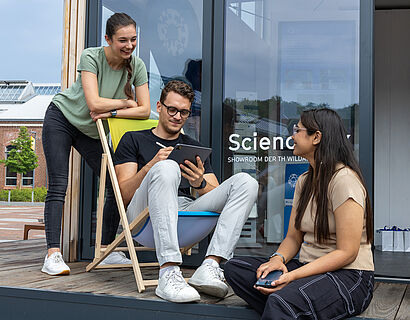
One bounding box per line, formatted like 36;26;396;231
53;47;148;139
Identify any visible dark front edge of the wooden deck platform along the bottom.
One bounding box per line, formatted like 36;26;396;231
0;286;259;320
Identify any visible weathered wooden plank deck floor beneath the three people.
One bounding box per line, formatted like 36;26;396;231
0;239;410;320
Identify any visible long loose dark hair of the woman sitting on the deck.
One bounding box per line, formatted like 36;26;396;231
295;108;373;243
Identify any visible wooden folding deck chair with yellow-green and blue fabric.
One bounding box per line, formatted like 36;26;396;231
86;118;219;292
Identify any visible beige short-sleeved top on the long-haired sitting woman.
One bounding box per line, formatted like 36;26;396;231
293;166;374;271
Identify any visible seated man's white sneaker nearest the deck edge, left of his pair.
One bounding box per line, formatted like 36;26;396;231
155;269;201;302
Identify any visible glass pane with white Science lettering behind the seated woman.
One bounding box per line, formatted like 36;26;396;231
222;0;360;254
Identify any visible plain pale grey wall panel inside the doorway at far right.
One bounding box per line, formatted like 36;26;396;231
374;10;410;232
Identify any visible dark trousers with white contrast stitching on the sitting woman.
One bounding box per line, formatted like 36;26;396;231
225;257;374;320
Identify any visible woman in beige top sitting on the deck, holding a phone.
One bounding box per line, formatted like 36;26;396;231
225;109;374;319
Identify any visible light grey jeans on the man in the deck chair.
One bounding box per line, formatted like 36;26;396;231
127;160;258;265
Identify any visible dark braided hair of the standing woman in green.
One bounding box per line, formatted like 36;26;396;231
105;12;137;99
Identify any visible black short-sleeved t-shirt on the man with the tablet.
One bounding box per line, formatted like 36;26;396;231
114;129;213;198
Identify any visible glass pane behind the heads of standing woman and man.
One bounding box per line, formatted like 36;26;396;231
101;0;203;140
